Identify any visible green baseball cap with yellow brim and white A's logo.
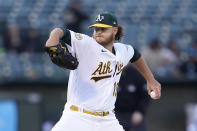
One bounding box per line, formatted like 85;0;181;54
88;13;118;28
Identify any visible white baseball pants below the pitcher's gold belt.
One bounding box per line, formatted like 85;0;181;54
51;104;124;131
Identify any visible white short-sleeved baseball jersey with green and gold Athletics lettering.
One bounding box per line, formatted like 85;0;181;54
67;31;134;111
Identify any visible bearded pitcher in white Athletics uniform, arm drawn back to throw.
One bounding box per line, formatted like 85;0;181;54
45;12;161;131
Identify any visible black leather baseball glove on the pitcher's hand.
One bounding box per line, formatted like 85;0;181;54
45;43;79;70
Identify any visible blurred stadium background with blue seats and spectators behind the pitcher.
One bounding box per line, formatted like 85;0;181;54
0;0;197;131
